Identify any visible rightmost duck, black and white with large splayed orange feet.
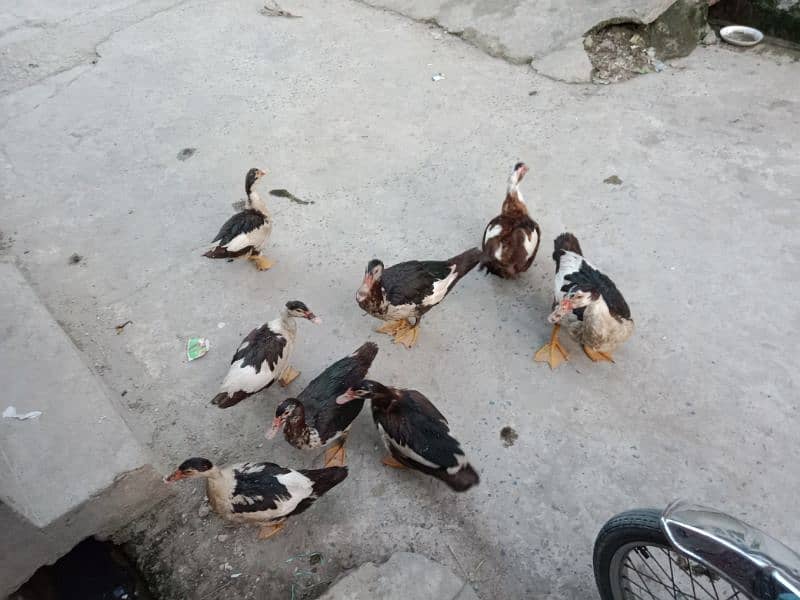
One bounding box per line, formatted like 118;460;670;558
535;233;633;369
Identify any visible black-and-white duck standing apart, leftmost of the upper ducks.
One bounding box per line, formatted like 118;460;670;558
203;169;274;271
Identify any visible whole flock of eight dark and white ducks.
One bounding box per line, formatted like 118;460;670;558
166;163;633;539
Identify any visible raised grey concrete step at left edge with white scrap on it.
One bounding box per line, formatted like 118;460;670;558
0;262;165;598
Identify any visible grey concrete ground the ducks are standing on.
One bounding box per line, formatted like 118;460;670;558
0;0;800;599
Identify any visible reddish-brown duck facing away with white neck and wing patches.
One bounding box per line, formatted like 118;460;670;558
481;163;541;279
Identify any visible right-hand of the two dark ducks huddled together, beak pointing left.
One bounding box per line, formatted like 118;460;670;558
337;379;479;492
